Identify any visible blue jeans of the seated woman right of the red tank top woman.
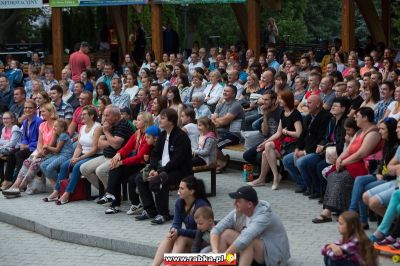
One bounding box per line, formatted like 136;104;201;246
349;175;385;224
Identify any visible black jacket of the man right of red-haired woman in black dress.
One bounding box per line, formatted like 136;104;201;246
296;108;331;153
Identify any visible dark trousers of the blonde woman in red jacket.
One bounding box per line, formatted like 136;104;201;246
107;164;144;206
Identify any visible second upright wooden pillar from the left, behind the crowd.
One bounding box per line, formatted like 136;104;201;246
151;3;163;62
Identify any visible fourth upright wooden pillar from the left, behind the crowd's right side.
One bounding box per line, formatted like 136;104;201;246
342;0;355;52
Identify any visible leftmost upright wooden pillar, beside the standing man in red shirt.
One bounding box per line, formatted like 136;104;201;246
51;7;64;79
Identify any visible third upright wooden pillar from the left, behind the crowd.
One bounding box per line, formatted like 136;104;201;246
247;0;261;57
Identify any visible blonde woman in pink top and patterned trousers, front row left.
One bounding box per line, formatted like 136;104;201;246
3;103;58;196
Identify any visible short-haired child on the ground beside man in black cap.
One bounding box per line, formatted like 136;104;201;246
192;206;215;253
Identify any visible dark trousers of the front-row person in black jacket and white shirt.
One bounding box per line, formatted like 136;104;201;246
136;171;183;217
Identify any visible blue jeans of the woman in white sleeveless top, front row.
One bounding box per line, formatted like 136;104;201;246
55;157;94;193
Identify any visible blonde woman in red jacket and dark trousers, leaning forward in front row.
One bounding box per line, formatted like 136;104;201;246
106;112;153;214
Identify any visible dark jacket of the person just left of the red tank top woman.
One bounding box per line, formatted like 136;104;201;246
318;115;347;156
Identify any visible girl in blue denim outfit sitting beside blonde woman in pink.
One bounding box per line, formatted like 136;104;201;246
40;119;74;202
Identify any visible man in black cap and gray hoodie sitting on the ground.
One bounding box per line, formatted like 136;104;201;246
211;186;290;266
